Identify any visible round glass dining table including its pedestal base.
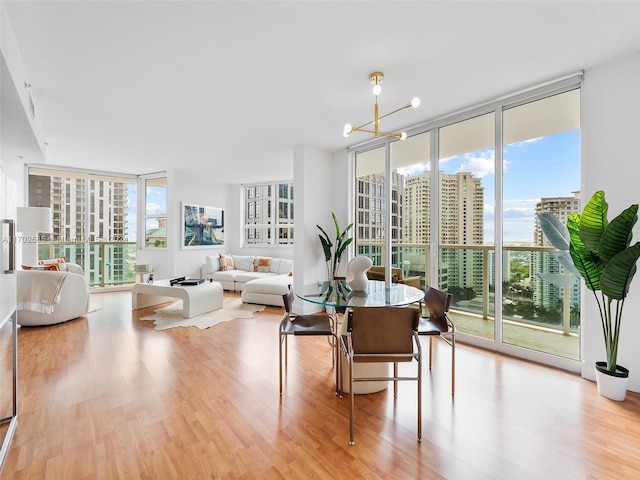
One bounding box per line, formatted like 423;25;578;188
296;280;424;394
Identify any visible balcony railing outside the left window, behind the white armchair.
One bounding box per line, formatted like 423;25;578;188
38;242;136;287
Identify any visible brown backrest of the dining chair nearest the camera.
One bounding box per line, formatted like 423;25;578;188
347;307;420;362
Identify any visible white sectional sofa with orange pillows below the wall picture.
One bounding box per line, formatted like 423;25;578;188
201;255;293;307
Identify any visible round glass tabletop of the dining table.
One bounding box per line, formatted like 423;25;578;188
296;280;424;308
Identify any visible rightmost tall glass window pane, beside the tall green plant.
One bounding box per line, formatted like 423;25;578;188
502;88;581;360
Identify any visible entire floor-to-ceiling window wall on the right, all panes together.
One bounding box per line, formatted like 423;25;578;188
354;76;581;368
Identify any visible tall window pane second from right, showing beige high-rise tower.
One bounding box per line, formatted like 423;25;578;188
438;112;496;339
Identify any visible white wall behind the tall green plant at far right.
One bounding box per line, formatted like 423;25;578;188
581;53;640;392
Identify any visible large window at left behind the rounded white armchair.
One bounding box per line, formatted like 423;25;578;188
28;166;137;286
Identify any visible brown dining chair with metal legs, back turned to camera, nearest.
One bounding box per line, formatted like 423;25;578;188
340;307;422;445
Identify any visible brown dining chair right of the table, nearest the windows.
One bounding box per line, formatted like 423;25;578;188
418;287;456;395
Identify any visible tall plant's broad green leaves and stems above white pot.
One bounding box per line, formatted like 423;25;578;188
567;191;640;372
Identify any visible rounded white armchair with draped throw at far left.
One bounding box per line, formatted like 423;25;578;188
17;263;90;326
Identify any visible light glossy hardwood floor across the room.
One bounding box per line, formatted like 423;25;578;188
0;293;640;480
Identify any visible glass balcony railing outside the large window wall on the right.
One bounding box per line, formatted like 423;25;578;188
356;242;580;358
